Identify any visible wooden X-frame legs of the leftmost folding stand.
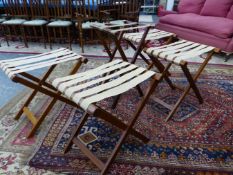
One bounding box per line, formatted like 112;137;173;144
15;60;86;138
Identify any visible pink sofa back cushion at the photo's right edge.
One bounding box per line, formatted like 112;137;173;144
201;0;233;17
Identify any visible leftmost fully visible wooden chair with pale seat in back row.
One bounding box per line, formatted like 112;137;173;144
2;0;29;46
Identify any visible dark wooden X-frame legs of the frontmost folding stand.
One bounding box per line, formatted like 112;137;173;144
64;74;162;175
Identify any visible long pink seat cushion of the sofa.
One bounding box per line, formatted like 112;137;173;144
160;13;233;38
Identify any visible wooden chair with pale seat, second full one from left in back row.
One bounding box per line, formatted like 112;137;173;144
22;0;48;48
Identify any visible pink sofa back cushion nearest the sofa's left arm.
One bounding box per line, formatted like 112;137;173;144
178;0;206;14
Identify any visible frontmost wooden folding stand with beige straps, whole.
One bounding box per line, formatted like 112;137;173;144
52;59;163;174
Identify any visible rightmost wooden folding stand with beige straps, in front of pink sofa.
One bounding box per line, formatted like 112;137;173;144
145;40;220;121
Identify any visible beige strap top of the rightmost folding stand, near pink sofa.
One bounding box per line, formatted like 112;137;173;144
144;40;214;64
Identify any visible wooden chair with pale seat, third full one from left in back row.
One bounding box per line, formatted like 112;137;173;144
46;0;72;49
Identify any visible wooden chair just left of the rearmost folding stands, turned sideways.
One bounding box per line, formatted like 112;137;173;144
74;0;99;53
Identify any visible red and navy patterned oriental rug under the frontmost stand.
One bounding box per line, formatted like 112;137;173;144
29;61;233;175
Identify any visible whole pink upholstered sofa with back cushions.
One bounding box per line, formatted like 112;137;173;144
157;0;233;56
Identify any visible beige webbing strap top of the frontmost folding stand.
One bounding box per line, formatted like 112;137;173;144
52;60;155;110
